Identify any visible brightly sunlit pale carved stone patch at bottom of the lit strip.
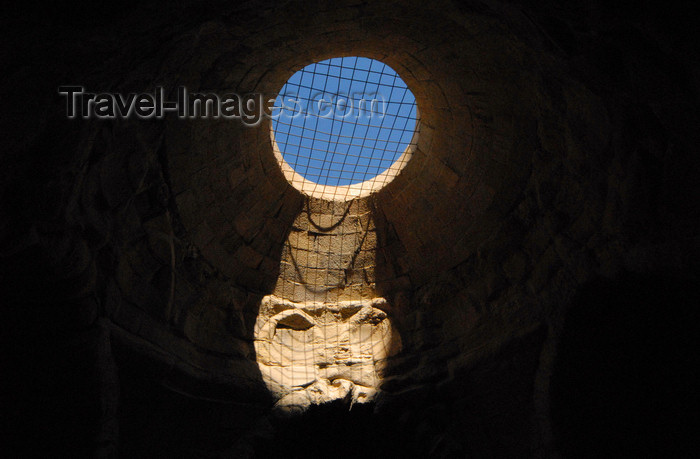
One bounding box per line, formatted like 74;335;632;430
255;295;401;411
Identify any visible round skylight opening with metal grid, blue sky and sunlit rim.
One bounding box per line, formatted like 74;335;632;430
272;56;418;201
